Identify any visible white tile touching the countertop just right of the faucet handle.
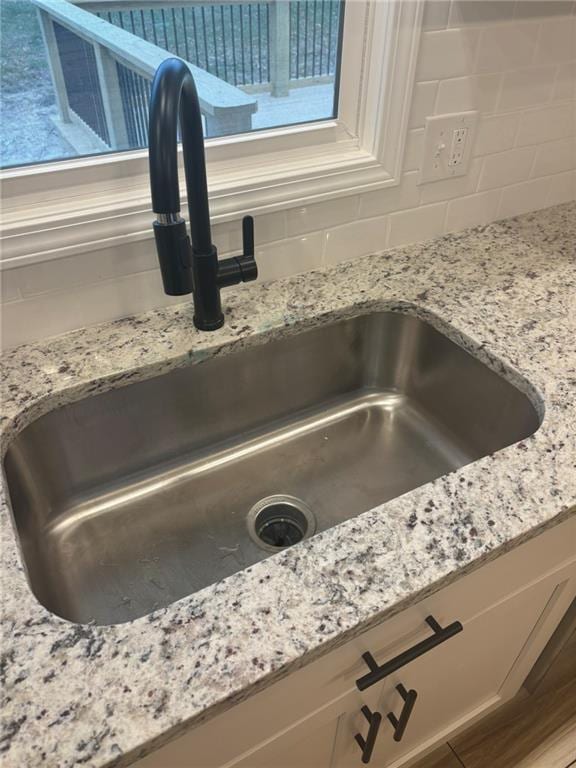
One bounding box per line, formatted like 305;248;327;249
256;232;323;283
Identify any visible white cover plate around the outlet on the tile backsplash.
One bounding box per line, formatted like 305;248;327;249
420;111;478;184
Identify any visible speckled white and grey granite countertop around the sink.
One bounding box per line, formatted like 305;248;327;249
0;203;576;768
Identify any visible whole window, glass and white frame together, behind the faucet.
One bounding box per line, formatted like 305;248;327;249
0;0;423;266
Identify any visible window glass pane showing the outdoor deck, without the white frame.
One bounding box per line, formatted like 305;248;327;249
0;0;344;167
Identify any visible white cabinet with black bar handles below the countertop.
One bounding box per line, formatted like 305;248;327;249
138;518;576;768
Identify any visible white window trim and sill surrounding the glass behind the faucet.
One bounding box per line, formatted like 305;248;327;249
0;0;423;269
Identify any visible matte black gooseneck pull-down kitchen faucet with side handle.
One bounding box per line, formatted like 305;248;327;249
149;59;258;331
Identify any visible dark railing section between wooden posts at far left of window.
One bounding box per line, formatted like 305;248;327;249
54;22;110;144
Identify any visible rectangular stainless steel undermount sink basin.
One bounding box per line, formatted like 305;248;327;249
5;312;539;624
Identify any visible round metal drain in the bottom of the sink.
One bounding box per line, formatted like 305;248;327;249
246;494;316;552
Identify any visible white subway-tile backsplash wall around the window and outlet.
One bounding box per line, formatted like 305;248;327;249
2;0;576;347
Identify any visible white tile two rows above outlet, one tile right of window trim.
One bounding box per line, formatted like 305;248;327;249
476;24;539;72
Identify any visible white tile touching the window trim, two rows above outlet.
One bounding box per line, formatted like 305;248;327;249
417;29;479;80
